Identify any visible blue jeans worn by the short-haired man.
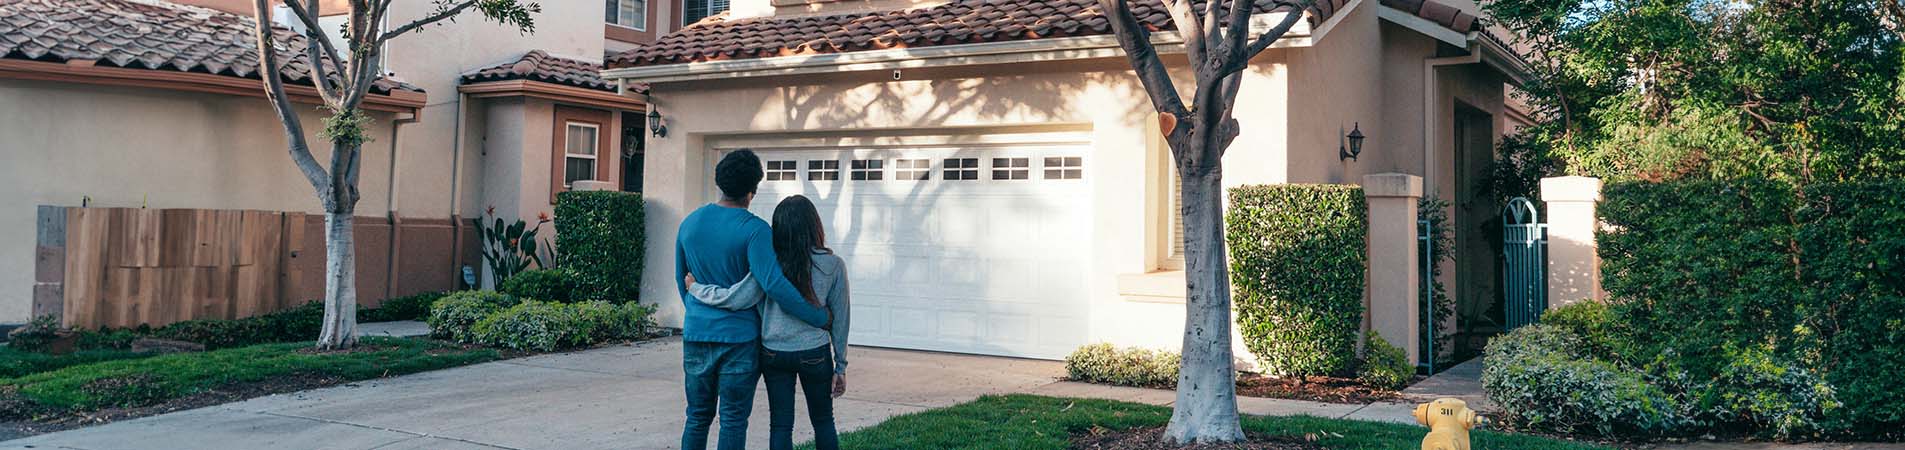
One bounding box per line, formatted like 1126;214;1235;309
682;341;760;450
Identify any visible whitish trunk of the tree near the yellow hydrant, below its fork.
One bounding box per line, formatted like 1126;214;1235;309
1164;158;1244;444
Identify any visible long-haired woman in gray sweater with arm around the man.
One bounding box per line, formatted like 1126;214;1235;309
686;194;850;450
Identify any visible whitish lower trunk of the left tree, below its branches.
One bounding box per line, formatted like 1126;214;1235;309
318;212;356;349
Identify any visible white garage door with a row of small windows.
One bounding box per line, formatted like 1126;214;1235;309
727;147;1092;358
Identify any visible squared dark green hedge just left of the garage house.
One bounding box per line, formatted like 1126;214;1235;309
556;191;648;301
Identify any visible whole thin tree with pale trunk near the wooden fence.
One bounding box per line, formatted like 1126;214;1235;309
251;0;541;349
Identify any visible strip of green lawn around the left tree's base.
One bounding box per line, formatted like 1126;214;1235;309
0;338;501;412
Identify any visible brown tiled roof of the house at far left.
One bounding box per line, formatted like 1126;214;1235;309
0;0;423;93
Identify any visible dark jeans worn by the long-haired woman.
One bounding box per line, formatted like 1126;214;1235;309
760;345;840;450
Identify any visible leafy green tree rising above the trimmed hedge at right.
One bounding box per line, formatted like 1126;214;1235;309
1484;0;1905;187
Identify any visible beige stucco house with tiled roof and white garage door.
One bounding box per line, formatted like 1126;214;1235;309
604;0;1522;358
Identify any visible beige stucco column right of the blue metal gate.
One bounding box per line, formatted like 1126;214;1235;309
1541;177;1604;309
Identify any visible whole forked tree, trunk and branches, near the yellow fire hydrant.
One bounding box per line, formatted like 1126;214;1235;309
1097;0;1313;444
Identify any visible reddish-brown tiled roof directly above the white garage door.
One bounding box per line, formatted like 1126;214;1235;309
606;0;1482;69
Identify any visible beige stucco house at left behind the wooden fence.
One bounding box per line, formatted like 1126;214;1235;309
0;0;669;326
